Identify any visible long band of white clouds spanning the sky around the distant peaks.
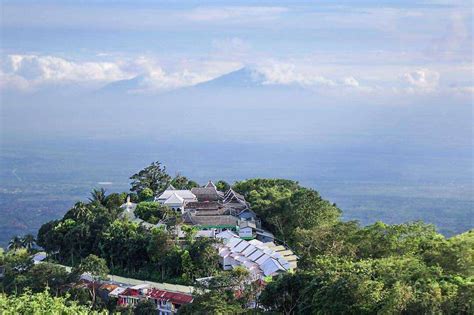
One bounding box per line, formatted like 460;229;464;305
0;54;473;99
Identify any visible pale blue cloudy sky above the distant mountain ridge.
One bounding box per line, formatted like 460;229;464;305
0;0;474;99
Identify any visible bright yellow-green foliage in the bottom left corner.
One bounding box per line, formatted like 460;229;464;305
0;291;97;315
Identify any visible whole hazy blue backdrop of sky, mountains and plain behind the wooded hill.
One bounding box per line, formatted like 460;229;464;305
0;0;474;244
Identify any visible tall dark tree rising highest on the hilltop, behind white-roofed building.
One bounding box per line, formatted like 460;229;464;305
130;162;171;195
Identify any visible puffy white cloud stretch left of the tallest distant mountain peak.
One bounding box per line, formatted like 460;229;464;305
0;55;216;91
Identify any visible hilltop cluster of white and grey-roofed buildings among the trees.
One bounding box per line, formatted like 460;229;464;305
122;181;297;280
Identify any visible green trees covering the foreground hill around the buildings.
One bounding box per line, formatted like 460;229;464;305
0;162;474;314
